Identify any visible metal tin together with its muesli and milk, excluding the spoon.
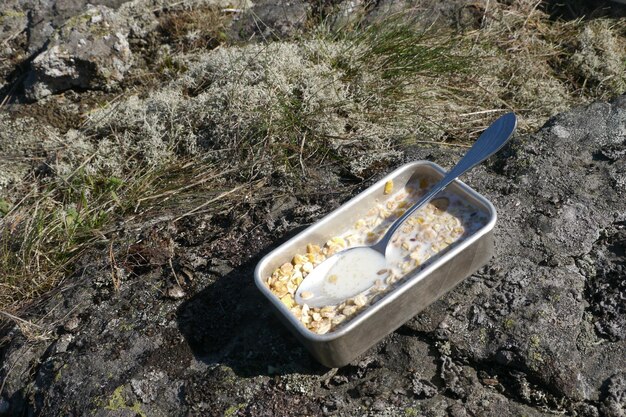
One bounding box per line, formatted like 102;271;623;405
255;161;496;366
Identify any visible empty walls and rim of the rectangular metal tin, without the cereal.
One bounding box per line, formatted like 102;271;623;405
254;161;496;368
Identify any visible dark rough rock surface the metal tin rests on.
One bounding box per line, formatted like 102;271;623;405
0;92;626;416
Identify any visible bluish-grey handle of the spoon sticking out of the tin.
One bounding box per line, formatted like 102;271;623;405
373;113;517;254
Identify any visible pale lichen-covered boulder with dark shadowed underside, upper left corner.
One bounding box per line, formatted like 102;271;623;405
24;6;133;100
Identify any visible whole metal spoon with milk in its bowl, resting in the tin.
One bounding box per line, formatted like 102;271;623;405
295;113;517;307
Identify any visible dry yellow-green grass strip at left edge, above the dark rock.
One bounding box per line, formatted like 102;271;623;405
0;155;246;311
